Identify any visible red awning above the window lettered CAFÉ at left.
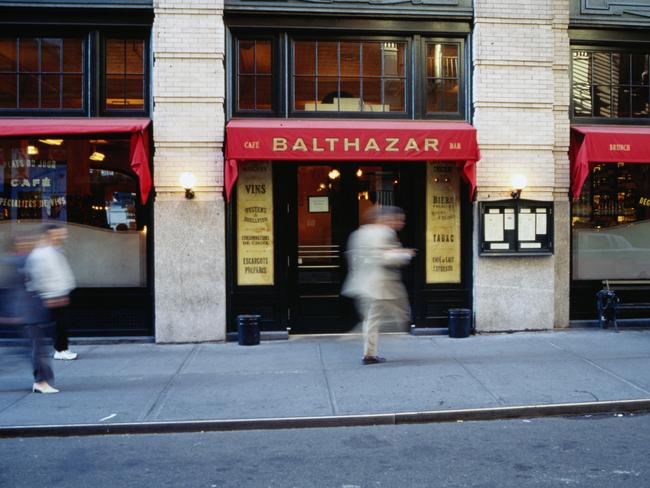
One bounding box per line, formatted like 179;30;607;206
0;117;152;203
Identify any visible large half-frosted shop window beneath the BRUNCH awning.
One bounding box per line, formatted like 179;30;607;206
572;163;650;280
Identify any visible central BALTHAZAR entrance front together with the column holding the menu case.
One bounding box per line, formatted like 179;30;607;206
224;1;569;332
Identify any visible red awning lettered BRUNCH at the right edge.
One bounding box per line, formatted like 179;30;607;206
569;125;650;198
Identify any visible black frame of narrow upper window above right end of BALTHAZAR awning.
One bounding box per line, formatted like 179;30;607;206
417;36;470;120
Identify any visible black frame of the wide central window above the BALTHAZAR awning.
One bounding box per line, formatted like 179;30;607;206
285;34;414;119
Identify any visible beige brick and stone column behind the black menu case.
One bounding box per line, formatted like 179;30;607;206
473;0;569;332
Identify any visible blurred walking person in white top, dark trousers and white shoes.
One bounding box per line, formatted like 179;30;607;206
27;224;77;360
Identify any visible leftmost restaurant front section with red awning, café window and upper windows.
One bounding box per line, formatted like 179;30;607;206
0;2;154;336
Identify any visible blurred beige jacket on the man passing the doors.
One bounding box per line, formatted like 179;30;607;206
341;224;411;300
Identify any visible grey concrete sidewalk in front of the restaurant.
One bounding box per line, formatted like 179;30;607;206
0;330;650;430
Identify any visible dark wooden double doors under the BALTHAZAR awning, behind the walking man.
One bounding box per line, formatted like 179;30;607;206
285;162;416;333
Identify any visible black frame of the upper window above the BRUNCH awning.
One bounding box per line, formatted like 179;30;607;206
569;44;650;125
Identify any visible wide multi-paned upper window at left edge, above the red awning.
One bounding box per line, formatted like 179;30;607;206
0;37;84;111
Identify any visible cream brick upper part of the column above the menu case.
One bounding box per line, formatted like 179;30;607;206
473;0;569;200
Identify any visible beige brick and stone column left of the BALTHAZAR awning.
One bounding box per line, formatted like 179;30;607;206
153;0;226;342
